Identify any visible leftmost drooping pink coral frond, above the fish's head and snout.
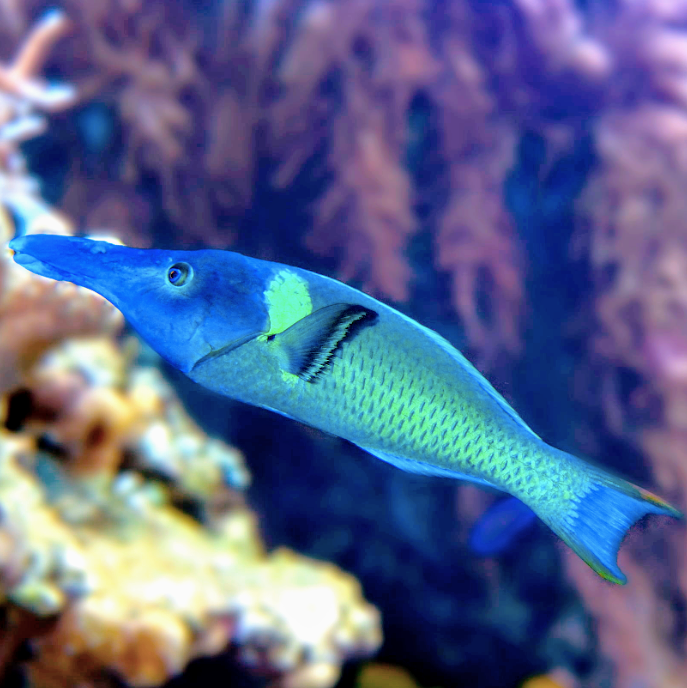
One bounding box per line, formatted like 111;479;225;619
62;2;211;236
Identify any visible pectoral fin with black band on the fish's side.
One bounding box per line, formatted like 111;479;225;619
267;303;377;382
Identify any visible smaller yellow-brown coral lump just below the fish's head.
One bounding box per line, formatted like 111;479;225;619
14;337;249;500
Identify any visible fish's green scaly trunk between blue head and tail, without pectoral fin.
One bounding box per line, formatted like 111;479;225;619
190;268;568;514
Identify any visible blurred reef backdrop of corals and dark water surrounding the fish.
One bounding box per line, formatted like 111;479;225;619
0;0;687;688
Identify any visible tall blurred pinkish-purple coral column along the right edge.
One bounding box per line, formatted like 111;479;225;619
568;2;687;688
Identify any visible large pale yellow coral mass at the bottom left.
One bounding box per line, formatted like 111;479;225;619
0;412;380;687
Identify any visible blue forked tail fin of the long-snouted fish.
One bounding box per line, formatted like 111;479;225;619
546;467;682;585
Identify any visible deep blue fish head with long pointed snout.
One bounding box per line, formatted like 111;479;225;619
10;234;269;373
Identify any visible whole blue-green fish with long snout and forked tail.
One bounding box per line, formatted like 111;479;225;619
11;236;679;583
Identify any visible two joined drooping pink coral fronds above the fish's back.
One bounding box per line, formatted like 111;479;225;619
274;0;523;362
